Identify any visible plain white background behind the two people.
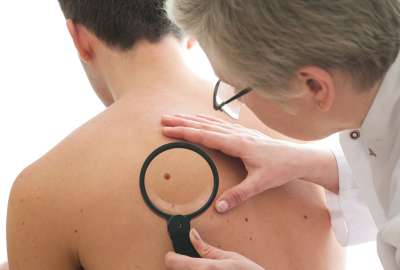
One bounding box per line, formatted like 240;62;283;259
0;0;382;270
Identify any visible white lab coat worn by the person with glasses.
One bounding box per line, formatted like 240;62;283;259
327;51;400;270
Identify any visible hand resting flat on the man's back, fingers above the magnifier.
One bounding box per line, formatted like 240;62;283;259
161;115;339;213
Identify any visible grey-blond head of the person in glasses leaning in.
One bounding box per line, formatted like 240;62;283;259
167;0;400;137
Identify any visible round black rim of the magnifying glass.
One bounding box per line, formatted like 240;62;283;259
139;142;219;220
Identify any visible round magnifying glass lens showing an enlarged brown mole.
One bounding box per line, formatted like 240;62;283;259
144;148;214;215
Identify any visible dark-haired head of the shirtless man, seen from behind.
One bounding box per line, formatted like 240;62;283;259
59;0;181;105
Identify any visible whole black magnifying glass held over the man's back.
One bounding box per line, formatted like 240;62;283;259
140;142;219;258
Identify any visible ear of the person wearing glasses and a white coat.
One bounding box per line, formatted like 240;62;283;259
297;66;336;112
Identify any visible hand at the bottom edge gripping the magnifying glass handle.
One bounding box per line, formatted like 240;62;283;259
165;230;264;270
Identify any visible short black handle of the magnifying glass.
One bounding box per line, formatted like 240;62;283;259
168;216;200;258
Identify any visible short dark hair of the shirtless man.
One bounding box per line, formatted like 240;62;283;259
59;0;181;50
